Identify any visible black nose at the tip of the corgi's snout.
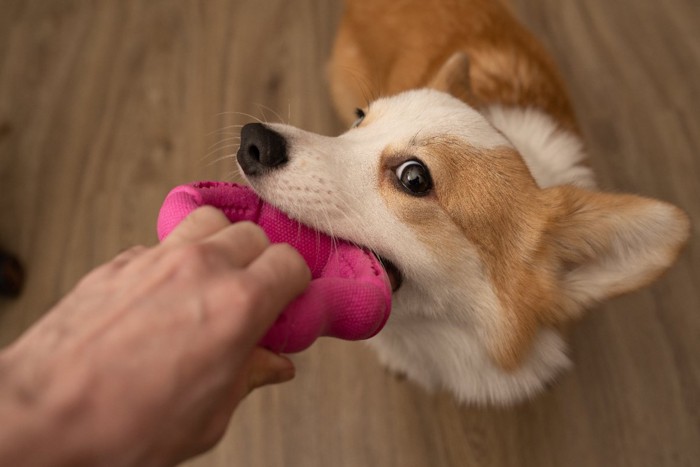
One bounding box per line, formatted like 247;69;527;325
236;123;288;175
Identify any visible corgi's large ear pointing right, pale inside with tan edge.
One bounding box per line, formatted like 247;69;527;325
545;187;690;317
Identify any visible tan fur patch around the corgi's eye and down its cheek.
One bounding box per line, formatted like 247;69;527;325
381;138;553;368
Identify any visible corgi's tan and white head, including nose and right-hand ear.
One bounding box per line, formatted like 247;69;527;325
238;90;689;368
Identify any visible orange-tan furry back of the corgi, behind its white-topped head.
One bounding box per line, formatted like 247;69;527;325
329;0;578;131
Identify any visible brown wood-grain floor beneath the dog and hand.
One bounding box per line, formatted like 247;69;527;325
0;0;700;467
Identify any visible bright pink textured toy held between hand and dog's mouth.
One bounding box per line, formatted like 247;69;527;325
158;182;391;353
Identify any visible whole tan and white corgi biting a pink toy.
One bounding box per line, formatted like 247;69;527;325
237;0;690;405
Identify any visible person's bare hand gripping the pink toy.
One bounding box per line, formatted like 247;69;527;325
0;207;310;465
